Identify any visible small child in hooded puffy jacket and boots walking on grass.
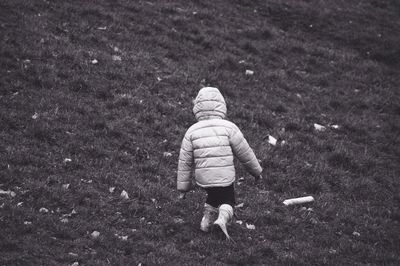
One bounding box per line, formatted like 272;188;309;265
177;87;262;239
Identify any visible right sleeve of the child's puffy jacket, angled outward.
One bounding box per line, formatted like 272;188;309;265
230;126;262;177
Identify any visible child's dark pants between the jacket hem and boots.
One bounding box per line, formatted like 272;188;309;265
205;184;235;208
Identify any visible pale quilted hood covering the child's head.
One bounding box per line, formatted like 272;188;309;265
193;87;226;121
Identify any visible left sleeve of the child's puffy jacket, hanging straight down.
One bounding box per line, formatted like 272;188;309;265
177;132;193;192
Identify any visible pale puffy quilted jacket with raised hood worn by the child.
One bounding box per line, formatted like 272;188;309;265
177;87;262;191
